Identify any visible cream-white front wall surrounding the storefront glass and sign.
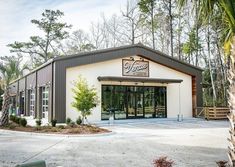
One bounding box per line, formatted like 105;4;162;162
66;56;192;122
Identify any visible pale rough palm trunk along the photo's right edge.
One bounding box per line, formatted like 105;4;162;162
228;37;235;166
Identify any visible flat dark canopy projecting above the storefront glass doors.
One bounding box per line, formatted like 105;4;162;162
97;76;183;84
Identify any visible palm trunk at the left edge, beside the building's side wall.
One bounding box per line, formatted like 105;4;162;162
0;87;10;126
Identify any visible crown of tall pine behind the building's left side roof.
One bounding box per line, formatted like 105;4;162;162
8;10;71;66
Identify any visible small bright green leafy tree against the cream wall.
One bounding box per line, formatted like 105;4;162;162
72;76;98;124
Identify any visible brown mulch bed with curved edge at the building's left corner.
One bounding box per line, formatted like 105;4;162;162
0;122;110;134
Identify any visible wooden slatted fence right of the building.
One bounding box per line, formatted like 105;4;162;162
195;107;229;120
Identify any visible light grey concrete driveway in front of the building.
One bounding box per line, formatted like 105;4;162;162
0;119;228;167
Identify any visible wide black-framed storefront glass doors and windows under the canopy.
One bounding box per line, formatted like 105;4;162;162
101;85;167;120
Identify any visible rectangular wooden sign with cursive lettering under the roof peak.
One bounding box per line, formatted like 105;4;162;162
122;59;149;77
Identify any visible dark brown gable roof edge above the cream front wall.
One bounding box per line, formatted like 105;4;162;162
11;43;203;83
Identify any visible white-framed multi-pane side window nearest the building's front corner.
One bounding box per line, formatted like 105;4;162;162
42;87;49;118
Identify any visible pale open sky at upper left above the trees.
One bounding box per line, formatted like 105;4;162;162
0;0;127;56
